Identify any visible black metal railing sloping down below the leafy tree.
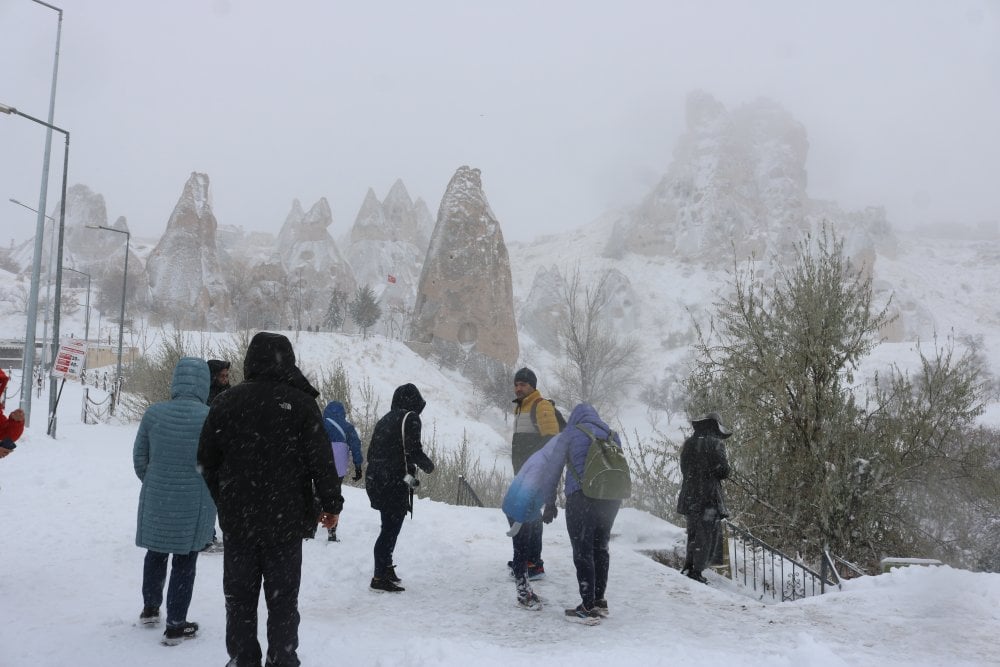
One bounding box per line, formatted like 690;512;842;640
725;520;838;602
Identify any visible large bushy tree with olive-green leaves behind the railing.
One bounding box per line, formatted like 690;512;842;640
686;228;984;567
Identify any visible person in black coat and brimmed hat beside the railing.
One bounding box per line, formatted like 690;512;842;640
677;412;732;584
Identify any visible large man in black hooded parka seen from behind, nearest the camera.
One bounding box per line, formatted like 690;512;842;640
198;332;344;667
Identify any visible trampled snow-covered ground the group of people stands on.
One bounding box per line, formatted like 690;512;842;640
0;382;1000;667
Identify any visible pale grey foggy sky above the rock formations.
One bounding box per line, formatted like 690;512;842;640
0;0;1000;245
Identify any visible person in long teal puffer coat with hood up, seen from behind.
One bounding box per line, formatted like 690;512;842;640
132;357;215;645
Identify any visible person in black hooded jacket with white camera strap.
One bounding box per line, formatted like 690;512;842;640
365;384;434;593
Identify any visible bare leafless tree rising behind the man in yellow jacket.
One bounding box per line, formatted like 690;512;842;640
555;267;640;410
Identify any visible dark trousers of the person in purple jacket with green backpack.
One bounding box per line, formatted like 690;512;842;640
566;491;622;609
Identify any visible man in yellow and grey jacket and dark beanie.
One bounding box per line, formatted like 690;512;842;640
508;368;559;580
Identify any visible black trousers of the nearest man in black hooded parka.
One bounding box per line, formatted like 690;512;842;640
222;539;302;667
